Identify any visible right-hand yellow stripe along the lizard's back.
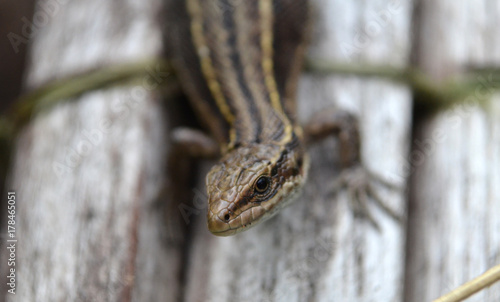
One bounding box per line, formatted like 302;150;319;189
259;0;292;142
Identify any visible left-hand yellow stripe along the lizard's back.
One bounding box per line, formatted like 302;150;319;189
187;0;234;125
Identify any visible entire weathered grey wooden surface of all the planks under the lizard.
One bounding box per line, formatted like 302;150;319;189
0;0;500;301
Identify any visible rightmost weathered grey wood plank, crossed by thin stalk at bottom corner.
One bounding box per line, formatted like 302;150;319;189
405;0;500;301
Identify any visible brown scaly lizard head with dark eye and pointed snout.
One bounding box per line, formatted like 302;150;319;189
206;142;309;236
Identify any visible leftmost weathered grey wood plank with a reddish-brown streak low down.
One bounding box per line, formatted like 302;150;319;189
1;0;181;301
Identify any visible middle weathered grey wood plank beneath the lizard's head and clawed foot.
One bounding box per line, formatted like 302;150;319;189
182;1;411;301
